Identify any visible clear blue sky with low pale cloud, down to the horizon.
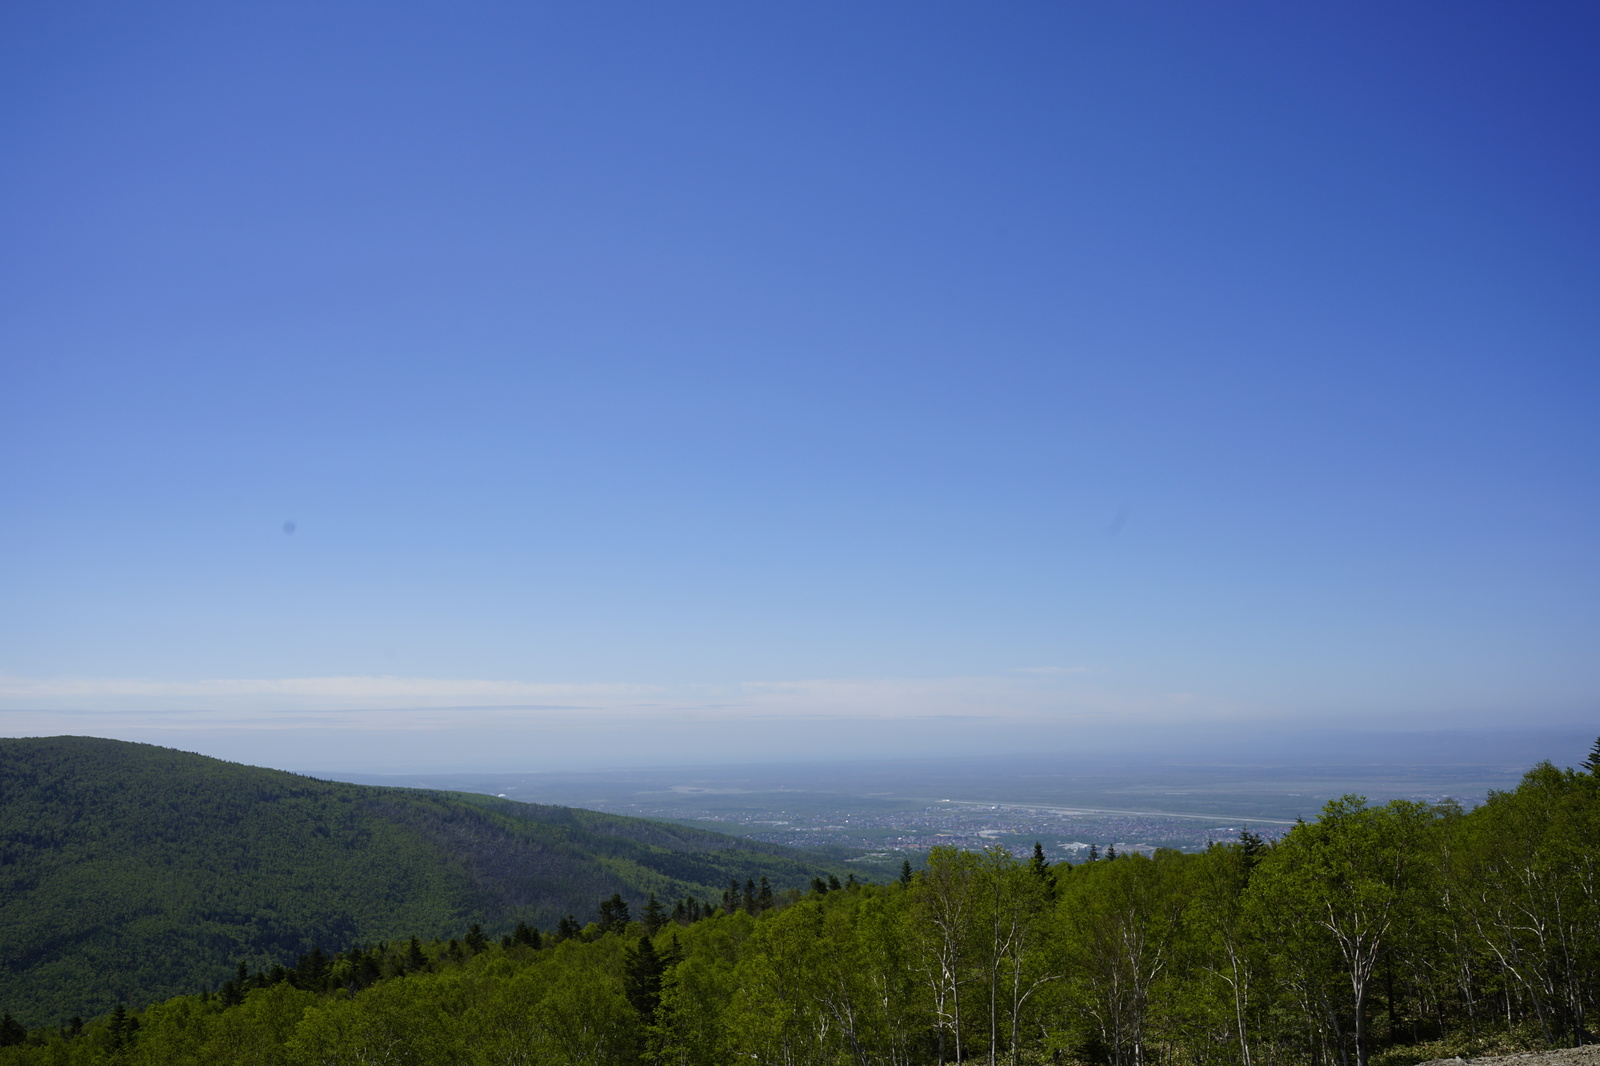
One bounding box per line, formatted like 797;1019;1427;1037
0;3;1600;768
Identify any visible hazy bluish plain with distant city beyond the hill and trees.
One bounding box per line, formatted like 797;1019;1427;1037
324;745;1525;869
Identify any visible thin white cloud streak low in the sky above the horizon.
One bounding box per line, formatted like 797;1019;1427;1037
0;667;1243;733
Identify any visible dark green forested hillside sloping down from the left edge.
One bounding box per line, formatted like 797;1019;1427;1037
0;736;827;1024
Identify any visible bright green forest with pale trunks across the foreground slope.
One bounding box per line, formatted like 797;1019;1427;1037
0;743;1600;1066
